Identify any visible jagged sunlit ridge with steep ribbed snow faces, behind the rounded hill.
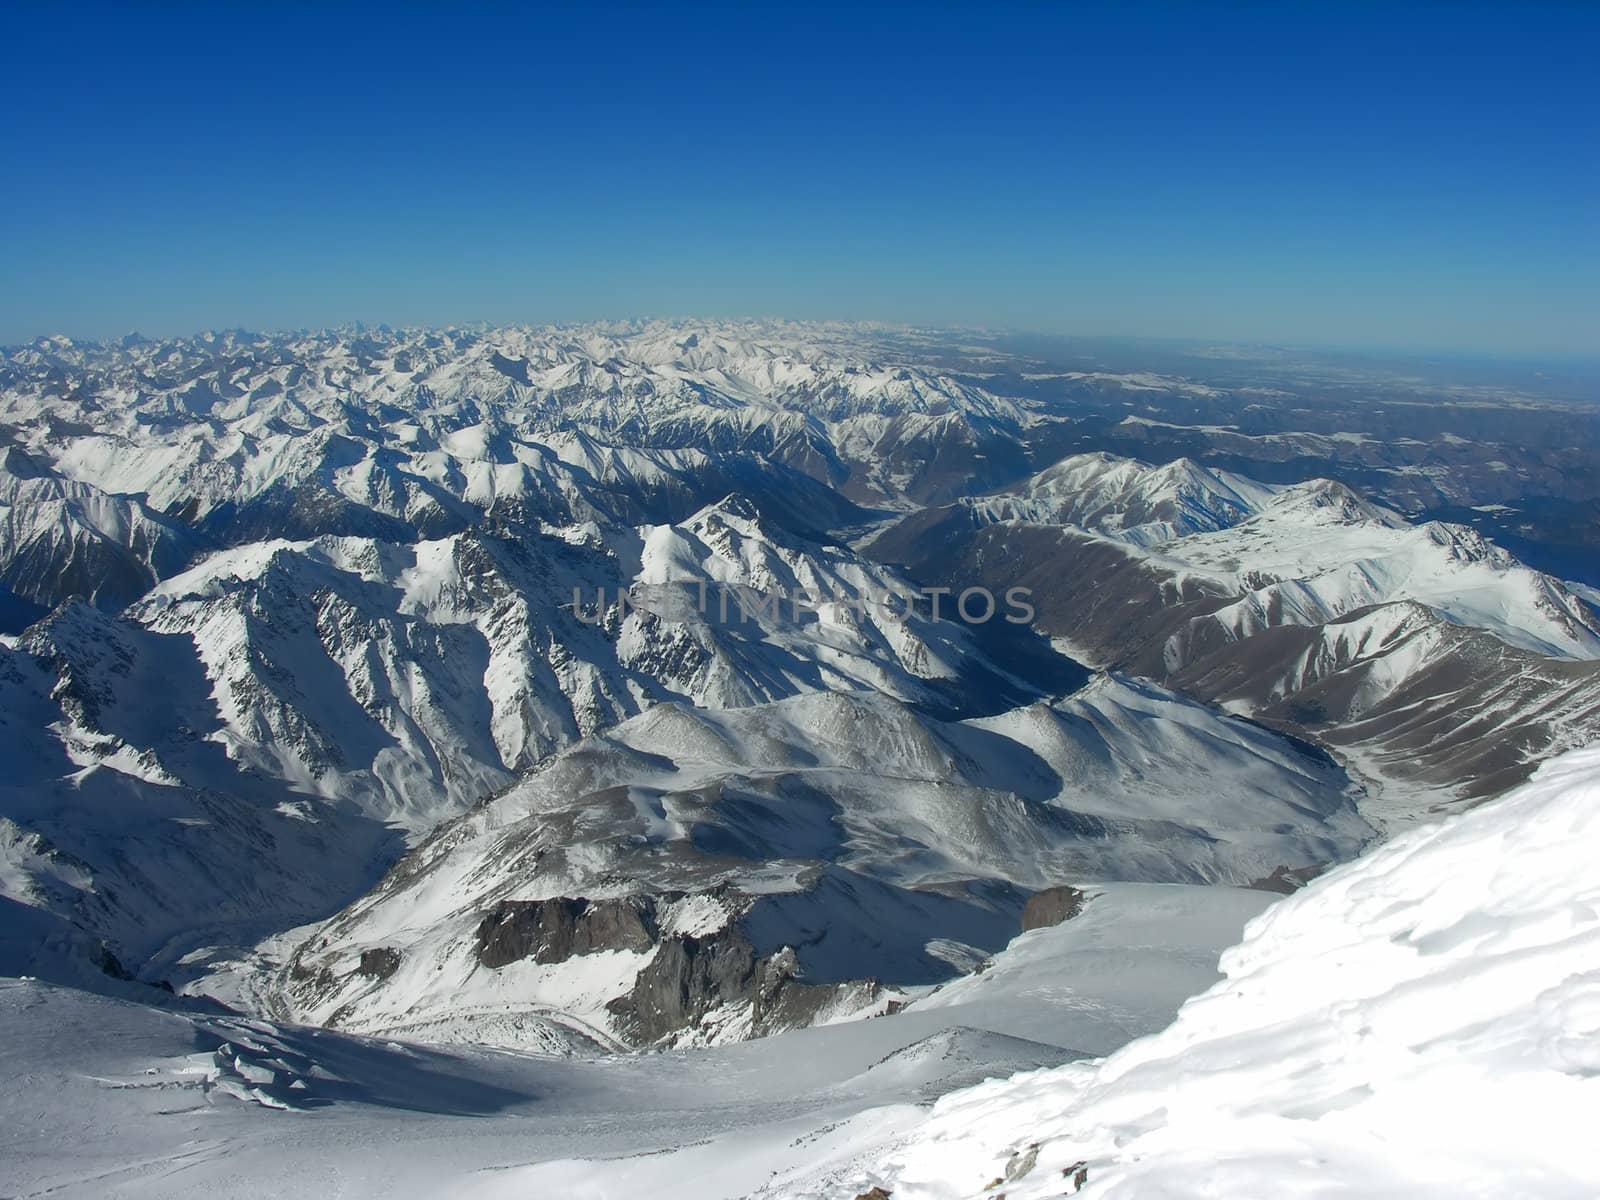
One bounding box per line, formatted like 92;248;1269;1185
130;501;1022;830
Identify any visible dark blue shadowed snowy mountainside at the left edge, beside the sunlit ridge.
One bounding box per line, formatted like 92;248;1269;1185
0;603;400;984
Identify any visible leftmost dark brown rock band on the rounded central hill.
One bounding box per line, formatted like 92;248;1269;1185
477;896;658;968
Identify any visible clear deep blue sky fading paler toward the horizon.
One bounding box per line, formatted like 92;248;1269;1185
0;2;1600;352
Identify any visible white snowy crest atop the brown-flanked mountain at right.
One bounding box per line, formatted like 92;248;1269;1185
962;453;1600;661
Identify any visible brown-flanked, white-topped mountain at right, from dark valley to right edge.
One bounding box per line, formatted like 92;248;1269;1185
866;459;1600;821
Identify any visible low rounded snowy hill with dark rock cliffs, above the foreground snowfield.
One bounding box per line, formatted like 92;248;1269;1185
268;678;1370;1043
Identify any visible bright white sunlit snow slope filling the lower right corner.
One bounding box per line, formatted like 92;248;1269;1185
771;749;1600;1200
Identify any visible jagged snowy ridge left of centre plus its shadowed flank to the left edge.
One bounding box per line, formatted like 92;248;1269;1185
0;502;1062;973
